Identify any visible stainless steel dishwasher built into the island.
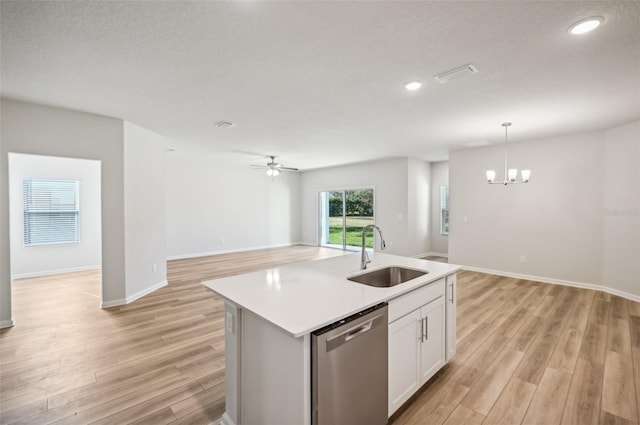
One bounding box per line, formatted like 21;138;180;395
311;303;388;425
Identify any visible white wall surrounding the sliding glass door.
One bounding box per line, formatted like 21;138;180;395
301;158;429;255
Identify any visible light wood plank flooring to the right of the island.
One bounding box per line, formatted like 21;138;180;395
392;272;640;425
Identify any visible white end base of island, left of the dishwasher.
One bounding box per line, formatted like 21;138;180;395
222;302;311;425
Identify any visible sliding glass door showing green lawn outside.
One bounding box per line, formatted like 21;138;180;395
319;188;375;251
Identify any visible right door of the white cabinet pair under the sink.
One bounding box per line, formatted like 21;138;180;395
418;297;445;385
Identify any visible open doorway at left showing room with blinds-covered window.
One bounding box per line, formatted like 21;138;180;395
9;153;102;314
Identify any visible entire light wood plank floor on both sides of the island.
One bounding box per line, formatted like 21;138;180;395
0;247;640;425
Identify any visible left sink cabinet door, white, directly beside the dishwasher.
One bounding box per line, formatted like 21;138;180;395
389;310;421;416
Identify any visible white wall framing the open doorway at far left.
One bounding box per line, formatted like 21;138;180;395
0;99;125;326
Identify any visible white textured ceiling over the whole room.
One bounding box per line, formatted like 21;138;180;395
0;1;640;169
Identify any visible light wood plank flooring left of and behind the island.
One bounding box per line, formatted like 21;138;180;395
0;246;343;424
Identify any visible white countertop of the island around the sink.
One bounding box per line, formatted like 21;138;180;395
203;252;460;337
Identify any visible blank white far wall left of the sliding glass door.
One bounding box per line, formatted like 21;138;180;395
166;152;300;259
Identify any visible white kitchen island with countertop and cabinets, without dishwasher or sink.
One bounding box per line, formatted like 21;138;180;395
203;253;459;425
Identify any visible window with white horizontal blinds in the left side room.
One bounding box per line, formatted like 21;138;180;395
22;179;80;246
